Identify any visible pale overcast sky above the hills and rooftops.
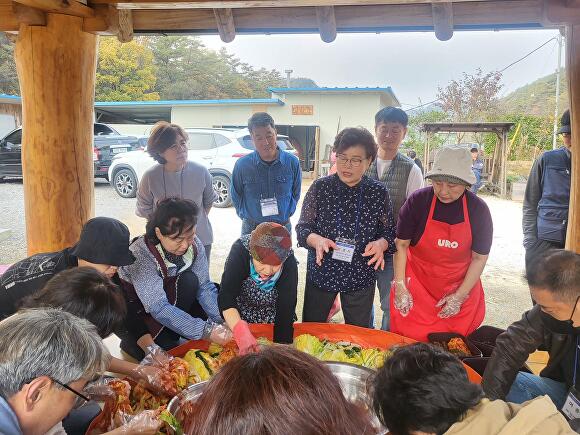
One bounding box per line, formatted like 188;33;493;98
202;30;565;108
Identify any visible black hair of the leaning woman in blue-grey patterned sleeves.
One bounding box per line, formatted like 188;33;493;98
145;198;199;244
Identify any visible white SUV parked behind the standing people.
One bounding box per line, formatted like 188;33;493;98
109;128;296;207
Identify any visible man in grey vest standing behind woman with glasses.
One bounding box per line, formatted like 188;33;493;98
366;107;423;331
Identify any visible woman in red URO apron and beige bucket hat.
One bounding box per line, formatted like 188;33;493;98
391;146;493;341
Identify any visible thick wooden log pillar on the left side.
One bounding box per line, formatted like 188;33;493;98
15;14;97;255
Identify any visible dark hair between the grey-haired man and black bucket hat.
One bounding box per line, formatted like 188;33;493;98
20;267;127;338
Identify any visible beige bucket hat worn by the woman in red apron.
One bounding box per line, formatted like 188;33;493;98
425;145;477;186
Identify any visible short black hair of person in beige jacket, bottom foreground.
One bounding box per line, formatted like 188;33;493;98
371;343;483;435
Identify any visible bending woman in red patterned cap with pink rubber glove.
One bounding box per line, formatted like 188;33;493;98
218;222;298;354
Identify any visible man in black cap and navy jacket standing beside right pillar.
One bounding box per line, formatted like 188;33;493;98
522;110;572;269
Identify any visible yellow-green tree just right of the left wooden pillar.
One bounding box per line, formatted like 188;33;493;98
95;37;159;101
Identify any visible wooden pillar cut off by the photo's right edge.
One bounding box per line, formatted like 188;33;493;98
566;25;580;254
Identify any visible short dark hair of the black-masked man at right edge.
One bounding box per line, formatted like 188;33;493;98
526;249;580;303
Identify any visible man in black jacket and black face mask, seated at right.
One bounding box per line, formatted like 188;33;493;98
483;249;580;409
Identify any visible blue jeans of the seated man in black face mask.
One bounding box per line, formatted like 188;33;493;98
505;372;568;409
